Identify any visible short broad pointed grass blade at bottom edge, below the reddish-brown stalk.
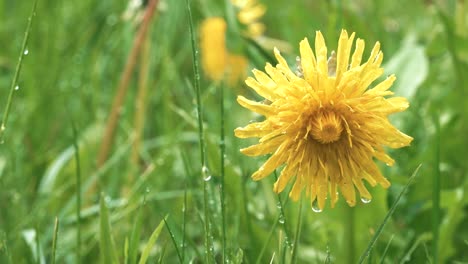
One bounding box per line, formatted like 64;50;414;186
99;194;119;264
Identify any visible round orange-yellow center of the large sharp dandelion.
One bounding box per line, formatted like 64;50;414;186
310;112;343;144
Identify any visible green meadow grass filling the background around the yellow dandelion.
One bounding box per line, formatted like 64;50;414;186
0;0;468;263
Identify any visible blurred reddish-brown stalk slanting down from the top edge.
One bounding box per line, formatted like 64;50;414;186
96;0;158;168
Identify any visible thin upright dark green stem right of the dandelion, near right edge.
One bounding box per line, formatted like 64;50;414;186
432;116;440;264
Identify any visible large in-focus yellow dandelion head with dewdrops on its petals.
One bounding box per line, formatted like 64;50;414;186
235;30;412;211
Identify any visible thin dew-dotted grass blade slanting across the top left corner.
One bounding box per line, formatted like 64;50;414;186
0;0;38;143
